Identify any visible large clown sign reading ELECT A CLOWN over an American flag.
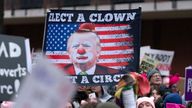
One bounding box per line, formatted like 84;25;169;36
43;8;141;85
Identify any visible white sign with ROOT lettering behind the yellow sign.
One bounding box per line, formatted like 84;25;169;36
142;49;174;76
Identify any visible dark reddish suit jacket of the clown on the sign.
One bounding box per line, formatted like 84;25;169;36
64;64;121;75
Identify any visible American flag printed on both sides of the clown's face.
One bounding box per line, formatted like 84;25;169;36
44;23;134;69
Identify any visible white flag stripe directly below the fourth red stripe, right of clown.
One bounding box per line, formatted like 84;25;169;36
98;58;132;63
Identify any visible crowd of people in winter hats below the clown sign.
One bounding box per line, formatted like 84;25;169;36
60;69;191;108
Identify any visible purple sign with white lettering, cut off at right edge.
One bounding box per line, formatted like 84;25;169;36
185;66;192;101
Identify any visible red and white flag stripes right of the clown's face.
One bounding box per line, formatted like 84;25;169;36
96;24;134;69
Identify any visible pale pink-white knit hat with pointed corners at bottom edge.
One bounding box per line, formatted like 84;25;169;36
137;97;155;108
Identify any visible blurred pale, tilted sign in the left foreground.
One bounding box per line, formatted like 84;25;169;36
13;59;75;108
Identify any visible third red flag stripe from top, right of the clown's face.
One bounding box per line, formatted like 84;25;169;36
101;46;133;51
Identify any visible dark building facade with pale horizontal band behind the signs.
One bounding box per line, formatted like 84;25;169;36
3;0;192;76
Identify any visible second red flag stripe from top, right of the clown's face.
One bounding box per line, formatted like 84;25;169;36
100;38;133;43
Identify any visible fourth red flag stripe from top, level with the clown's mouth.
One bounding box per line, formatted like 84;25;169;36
99;54;133;59
